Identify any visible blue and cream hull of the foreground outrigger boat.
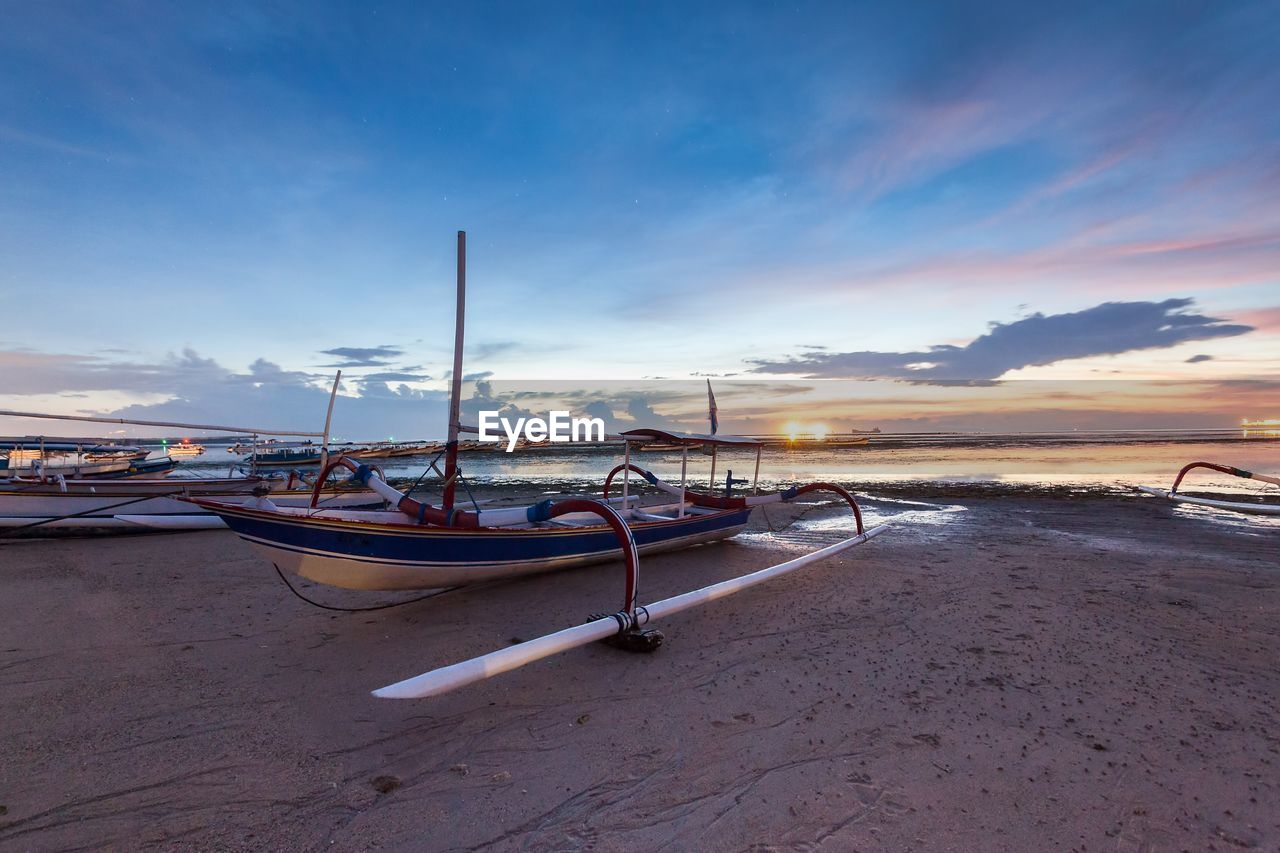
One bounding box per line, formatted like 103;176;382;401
201;497;750;589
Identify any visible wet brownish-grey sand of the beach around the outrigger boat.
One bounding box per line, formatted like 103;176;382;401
0;496;1280;850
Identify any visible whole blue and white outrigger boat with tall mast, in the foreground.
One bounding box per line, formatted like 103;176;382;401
188;232;886;699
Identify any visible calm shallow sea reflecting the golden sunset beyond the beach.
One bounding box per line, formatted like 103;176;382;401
184;437;1280;496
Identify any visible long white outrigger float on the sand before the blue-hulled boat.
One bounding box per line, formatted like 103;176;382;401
374;525;888;699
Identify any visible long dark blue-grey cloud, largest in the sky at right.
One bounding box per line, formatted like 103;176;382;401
749;298;1253;382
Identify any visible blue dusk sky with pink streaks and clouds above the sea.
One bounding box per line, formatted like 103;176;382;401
0;0;1280;438
